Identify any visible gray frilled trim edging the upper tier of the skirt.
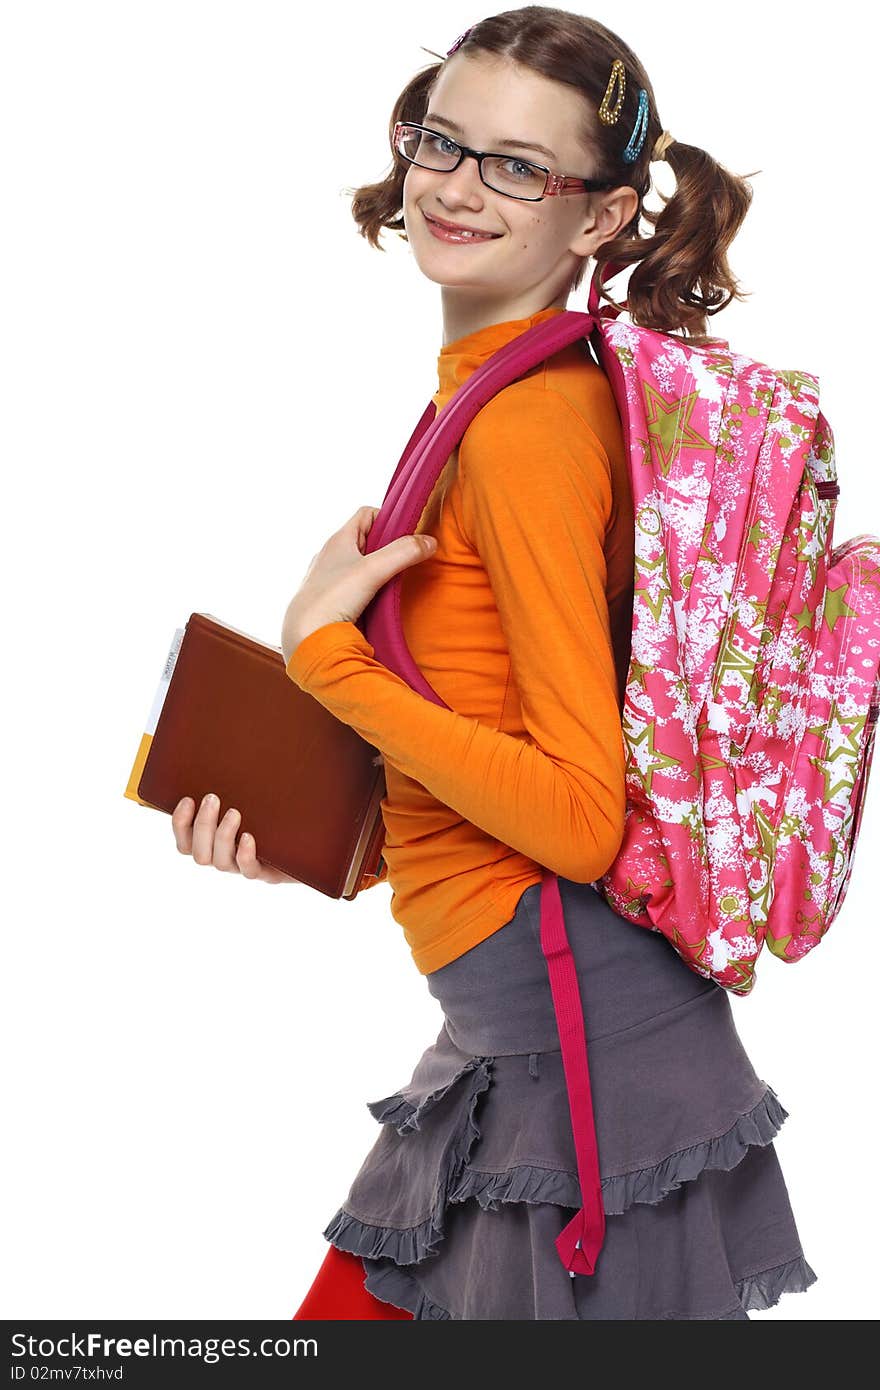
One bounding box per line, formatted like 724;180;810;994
324;1084;788;1265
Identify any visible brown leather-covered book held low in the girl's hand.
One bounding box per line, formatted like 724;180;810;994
125;613;385;899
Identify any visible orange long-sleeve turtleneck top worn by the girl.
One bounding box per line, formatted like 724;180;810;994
286;307;634;974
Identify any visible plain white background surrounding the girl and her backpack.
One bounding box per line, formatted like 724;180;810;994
0;0;880;1321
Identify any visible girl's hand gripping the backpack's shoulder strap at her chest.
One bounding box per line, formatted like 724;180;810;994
281;507;437;664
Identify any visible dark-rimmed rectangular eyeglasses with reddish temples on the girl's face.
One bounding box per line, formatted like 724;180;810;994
391;121;616;203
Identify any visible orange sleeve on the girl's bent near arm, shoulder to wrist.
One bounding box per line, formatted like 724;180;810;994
286;379;626;883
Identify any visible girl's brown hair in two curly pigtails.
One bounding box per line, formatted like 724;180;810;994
346;4;760;343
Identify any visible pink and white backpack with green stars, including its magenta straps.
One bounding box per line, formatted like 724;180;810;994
360;267;880;1275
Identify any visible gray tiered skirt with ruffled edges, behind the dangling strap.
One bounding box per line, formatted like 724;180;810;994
324;877;816;1321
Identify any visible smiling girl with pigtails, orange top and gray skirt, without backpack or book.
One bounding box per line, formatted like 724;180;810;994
175;6;816;1319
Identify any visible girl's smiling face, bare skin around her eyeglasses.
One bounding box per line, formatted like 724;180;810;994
403;53;638;322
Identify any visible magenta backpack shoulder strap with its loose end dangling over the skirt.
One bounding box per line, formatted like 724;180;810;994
359;310;605;1277
